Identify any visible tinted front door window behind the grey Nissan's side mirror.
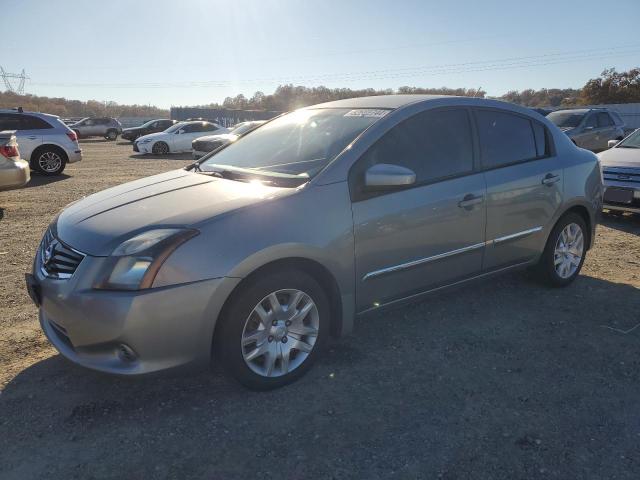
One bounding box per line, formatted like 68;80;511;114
358;110;473;183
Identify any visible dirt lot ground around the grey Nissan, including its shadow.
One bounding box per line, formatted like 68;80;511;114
0;140;640;480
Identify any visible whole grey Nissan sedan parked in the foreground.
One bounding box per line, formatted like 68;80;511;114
27;95;602;389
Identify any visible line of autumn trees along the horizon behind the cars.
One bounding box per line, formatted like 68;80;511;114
0;67;640;118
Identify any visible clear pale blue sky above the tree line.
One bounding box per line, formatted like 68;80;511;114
0;0;640;108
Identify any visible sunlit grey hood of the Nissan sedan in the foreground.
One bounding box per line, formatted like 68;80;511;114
56;170;297;256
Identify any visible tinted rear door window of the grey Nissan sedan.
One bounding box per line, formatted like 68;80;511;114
476;110;538;168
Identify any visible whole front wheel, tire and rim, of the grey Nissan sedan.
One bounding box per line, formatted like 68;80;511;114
214;270;331;390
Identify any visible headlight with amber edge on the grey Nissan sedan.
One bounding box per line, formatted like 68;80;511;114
95;228;199;290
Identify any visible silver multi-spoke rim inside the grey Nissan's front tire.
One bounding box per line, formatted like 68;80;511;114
241;289;320;377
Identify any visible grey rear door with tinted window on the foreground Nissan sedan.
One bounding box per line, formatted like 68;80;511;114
475;108;563;271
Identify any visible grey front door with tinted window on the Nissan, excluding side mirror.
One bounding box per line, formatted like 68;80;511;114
349;108;485;311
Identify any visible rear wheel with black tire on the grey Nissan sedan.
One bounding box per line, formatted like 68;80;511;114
536;213;589;287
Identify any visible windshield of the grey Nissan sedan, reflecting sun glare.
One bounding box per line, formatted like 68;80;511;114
200;108;388;177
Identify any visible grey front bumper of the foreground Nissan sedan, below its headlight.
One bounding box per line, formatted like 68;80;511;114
33;248;238;375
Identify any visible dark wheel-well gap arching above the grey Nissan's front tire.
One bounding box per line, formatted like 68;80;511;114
213;257;342;338
